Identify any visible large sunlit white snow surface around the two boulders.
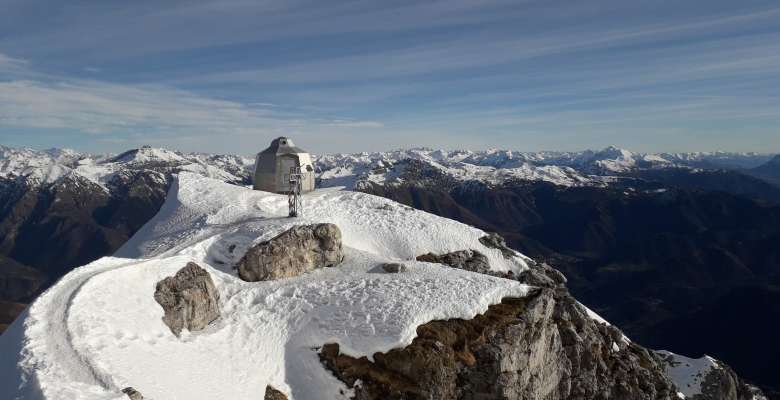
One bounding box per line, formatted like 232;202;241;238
0;172;528;400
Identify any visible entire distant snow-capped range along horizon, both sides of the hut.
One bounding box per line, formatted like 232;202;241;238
0;146;771;192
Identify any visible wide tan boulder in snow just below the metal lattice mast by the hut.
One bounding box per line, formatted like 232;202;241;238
237;224;344;282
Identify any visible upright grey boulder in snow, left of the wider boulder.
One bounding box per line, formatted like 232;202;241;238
154;262;220;336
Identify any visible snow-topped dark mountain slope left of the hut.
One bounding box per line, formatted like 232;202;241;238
0;146;250;332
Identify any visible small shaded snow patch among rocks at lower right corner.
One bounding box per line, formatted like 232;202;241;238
656;350;721;398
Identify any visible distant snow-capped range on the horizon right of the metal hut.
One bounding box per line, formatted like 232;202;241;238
316;147;770;189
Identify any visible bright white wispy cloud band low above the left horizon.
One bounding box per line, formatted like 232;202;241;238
0;62;383;153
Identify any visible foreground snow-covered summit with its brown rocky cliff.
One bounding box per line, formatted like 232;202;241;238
0;172;762;400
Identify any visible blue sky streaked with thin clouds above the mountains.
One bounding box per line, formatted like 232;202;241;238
0;0;780;154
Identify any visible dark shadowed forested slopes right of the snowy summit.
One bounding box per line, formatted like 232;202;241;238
366;183;780;394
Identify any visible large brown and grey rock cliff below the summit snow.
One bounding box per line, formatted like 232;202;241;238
320;289;677;400
